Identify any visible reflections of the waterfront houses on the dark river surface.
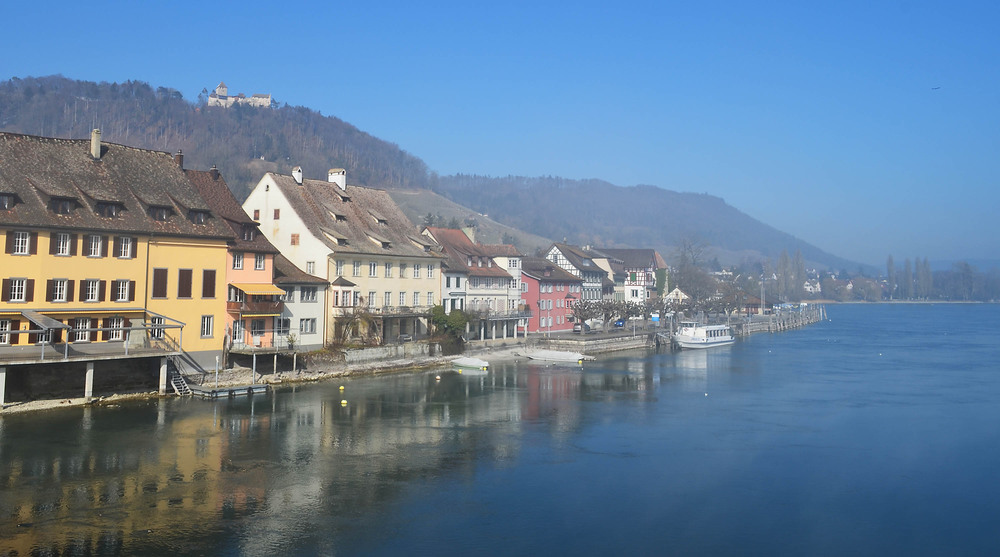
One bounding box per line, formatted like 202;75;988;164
0;358;658;554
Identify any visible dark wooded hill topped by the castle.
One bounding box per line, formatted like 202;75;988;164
0;76;429;199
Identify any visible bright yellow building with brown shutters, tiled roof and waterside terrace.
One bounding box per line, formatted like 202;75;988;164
0;130;233;403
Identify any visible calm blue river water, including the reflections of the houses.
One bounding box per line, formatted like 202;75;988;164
0;305;1000;555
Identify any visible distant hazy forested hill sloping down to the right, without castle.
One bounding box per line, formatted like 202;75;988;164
437;174;858;269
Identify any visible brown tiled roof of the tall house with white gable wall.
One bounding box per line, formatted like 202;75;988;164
267;172;439;258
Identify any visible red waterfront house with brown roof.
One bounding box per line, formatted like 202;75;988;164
521;257;583;334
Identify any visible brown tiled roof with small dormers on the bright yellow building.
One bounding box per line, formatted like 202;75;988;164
0;132;233;239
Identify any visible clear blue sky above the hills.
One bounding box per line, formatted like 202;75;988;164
0;1;1000;267
